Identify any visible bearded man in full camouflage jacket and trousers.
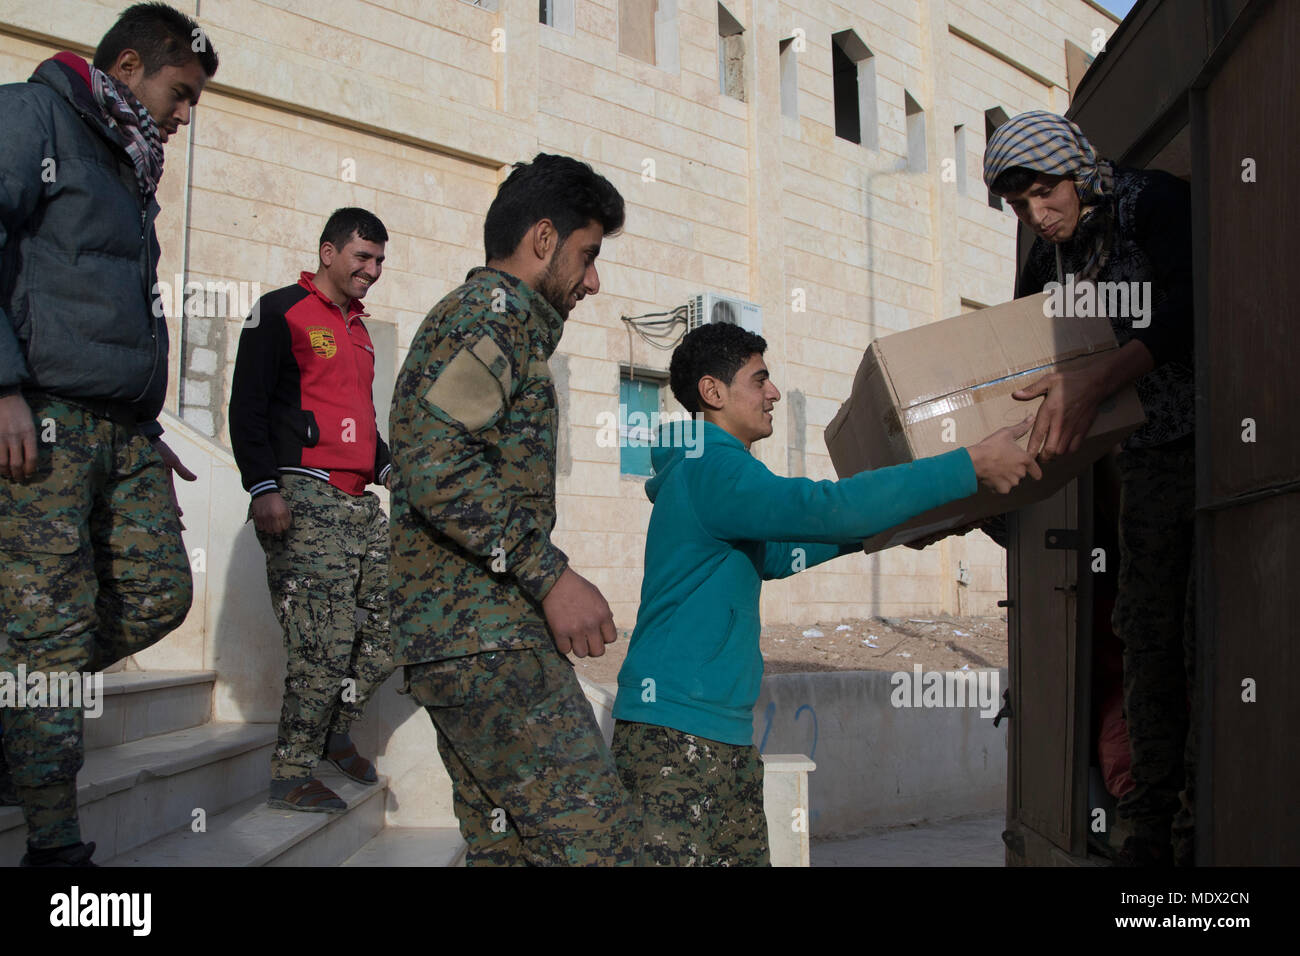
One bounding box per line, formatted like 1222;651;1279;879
391;153;638;865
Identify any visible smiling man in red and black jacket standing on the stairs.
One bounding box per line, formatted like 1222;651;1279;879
230;208;393;813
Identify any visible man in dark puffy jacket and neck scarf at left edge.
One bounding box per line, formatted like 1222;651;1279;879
0;4;217;865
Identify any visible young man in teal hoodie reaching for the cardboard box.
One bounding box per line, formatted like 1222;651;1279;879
612;324;1043;866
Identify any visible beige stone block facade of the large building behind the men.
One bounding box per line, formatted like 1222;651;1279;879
0;0;1117;627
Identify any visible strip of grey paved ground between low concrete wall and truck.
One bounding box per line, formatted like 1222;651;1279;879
813;810;1006;866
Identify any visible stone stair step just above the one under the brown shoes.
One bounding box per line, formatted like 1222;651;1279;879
0;723;276;866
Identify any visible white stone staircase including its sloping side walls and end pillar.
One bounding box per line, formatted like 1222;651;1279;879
0;415;813;866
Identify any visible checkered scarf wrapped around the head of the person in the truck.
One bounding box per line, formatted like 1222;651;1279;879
984;109;1115;278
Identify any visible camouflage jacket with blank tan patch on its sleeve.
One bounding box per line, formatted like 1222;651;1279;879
389;267;568;663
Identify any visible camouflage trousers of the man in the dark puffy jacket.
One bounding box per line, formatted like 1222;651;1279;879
0;393;192;849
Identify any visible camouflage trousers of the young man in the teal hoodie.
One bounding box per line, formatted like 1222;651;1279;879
612;721;771;866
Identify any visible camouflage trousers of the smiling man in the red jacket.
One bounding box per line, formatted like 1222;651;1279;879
250;473;394;780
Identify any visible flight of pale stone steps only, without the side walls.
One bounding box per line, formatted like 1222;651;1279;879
0;671;462;866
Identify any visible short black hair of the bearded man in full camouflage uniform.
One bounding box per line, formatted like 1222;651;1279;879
484;152;624;261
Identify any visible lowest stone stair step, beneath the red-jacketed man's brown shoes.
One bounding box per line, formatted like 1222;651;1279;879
104;770;387;866
